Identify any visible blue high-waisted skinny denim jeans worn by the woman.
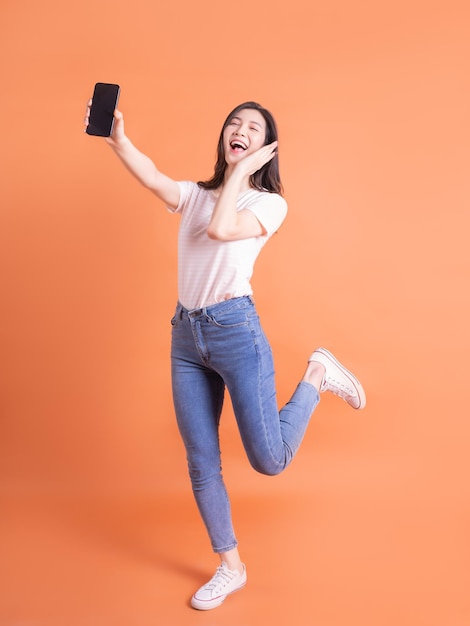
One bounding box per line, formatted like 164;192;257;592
171;296;319;553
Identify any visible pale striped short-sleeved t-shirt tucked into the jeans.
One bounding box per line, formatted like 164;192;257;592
170;181;287;310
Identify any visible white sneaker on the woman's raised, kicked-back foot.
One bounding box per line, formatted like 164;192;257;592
309;348;366;409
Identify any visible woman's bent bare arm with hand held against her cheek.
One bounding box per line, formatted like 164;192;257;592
207;141;277;241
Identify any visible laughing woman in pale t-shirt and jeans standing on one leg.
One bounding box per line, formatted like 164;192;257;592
85;101;366;610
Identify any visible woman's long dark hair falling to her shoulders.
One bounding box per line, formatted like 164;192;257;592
198;102;283;194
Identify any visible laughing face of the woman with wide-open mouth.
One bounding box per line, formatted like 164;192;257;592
223;109;266;165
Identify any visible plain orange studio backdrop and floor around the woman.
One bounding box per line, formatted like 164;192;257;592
0;0;470;626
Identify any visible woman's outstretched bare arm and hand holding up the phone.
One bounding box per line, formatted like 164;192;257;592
85;100;180;209
